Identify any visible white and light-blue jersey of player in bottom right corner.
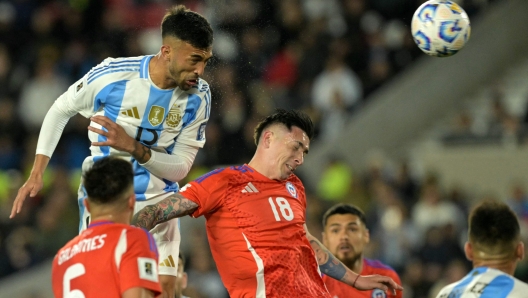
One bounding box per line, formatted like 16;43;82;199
436;267;528;298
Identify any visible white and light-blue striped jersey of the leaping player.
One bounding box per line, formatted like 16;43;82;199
58;56;211;201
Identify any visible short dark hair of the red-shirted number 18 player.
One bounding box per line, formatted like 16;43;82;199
253;109;314;145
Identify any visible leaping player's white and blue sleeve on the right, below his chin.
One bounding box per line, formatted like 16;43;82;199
176;80;211;148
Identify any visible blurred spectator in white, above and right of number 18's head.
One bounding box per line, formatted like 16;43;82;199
312;56;363;140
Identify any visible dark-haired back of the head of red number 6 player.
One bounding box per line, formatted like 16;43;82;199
83;156;135;218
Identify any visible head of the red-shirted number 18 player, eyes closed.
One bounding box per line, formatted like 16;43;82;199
254;109;314;180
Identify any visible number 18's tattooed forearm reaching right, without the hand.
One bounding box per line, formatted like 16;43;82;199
308;236;358;286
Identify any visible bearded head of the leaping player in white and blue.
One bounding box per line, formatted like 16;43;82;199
161;5;213;90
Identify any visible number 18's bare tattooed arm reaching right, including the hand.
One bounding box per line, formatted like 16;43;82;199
304;224;403;293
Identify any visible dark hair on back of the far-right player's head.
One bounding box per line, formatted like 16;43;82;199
469;200;520;255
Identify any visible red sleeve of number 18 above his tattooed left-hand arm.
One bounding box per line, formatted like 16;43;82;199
180;169;228;217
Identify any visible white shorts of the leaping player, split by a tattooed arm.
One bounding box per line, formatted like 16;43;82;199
134;193;181;276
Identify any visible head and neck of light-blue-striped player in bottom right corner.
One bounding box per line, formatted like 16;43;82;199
465;200;524;274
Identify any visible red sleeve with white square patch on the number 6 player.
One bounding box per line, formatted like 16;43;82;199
116;227;161;295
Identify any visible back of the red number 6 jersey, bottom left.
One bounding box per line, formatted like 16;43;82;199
52;221;159;298
